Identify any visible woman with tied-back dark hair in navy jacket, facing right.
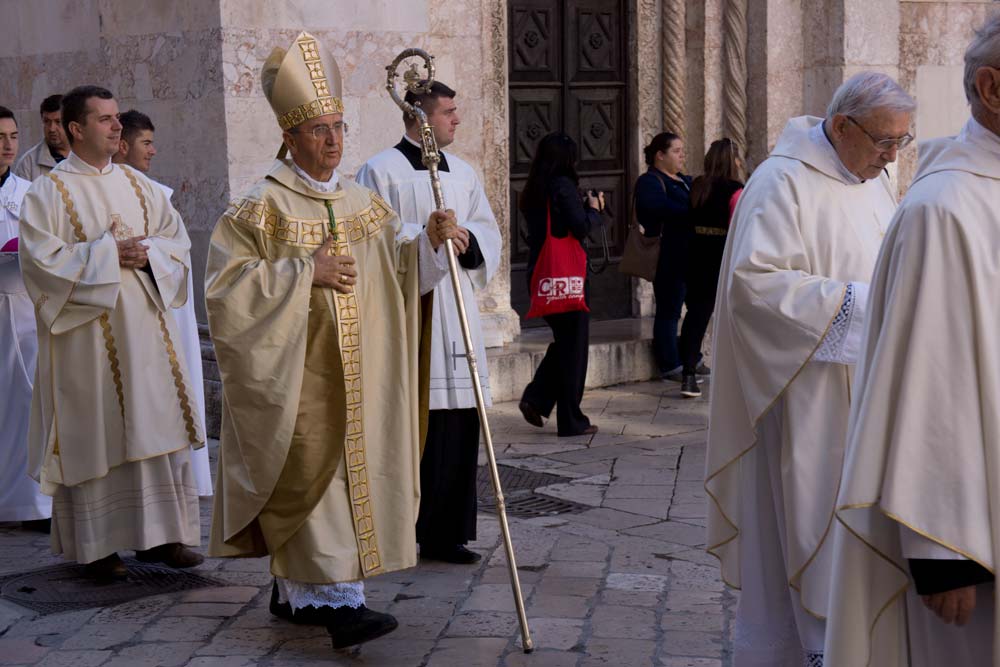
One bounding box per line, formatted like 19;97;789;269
635;132;691;379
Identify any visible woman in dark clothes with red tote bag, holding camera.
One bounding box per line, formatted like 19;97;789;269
519;132;603;437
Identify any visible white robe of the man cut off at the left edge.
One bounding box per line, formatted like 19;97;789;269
0;173;52;521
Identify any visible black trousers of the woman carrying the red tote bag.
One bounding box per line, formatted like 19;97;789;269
521;310;590;436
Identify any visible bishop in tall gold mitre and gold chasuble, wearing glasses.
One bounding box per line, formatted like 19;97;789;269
205;33;457;648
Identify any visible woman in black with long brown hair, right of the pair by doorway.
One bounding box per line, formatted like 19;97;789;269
680;139;743;398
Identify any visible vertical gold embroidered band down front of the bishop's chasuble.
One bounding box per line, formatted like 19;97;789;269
334;220;382;577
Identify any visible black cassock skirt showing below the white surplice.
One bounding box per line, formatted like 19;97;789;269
417;408;479;547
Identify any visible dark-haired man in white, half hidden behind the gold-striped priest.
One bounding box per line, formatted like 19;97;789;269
111;109;212;496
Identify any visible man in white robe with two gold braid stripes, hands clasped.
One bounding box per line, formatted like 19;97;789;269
19;86;205;578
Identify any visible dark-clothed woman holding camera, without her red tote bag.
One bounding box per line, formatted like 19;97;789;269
519;132;603;436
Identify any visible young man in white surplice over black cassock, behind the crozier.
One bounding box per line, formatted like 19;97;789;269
357;81;503;564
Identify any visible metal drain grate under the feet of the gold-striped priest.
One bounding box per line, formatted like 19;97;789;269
0;558;228;614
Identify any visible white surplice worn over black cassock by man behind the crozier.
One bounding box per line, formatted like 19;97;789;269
356;137;503;410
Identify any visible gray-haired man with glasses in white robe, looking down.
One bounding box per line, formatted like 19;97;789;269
705;72;916;667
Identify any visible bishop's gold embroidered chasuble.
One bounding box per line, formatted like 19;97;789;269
206;160;429;584
